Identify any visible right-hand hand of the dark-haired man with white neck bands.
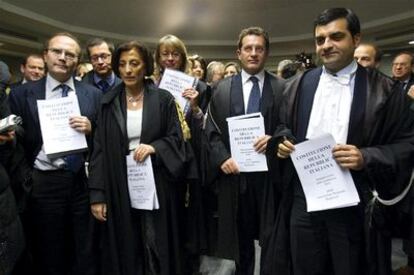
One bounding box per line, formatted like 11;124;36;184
332;144;364;171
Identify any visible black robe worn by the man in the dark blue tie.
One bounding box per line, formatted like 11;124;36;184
202;72;284;262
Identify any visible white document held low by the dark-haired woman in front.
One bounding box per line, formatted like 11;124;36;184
126;154;160;210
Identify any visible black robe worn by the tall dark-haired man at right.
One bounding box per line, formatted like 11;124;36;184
261;66;414;275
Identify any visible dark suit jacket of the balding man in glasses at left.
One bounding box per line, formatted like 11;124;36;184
9;78;102;165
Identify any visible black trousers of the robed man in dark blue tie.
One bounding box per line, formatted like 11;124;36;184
236;173;266;275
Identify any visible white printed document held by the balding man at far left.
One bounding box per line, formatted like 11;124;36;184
37;96;88;158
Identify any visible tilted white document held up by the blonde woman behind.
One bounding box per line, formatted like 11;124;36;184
158;69;198;111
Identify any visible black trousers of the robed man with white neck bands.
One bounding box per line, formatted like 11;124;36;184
290;182;364;275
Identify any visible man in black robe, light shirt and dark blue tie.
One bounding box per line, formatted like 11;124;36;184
205;27;284;274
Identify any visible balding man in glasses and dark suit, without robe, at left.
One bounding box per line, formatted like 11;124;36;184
9;33;102;274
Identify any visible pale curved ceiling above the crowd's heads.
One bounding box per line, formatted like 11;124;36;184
0;0;414;62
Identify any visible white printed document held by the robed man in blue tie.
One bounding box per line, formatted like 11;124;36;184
227;113;268;172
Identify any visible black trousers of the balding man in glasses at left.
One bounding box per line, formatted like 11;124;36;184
27;169;97;275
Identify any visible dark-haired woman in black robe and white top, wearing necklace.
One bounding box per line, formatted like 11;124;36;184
89;41;186;275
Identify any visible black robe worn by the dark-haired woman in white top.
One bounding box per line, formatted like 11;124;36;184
89;84;190;275
